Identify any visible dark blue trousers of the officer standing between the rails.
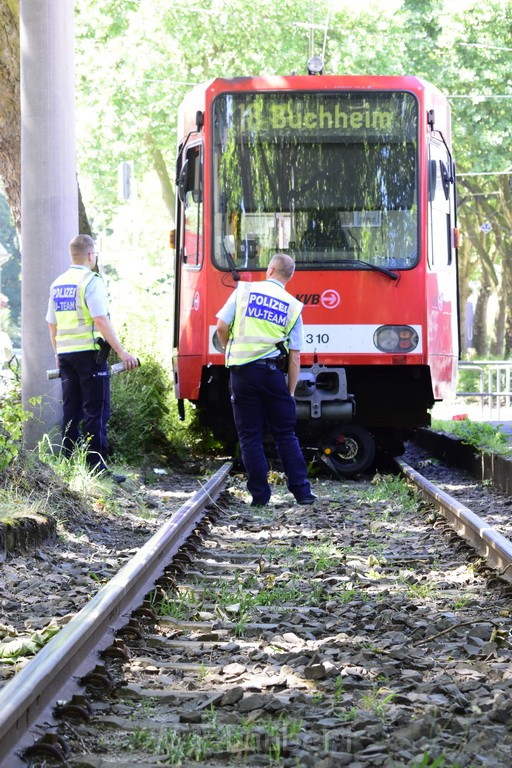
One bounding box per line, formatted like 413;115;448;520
230;360;311;504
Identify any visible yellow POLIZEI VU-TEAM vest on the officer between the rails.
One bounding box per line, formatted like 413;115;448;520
226;280;303;368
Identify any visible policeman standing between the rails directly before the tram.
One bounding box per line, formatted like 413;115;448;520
217;253;316;506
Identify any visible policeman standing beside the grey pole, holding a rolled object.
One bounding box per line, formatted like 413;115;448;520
46;235;138;482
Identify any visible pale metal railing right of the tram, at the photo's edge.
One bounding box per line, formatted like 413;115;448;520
457;360;512;420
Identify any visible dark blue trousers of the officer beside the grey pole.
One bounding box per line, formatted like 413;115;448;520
59;351;110;469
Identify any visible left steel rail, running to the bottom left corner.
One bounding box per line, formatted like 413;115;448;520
0;462;232;768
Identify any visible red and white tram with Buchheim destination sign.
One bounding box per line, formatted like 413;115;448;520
173;67;458;476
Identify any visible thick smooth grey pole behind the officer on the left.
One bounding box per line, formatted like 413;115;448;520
20;0;78;448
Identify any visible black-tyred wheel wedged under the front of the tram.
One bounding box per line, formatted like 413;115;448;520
321;424;375;477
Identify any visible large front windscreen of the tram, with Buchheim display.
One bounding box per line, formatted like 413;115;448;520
213;91;418;271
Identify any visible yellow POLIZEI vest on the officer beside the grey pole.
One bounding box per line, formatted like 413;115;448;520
51;268;101;353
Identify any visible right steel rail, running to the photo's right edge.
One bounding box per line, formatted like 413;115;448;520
395;458;512;583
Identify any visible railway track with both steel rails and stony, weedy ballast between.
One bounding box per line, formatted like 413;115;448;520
0;462;512;768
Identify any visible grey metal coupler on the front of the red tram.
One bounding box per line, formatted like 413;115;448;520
295;363;355;422
